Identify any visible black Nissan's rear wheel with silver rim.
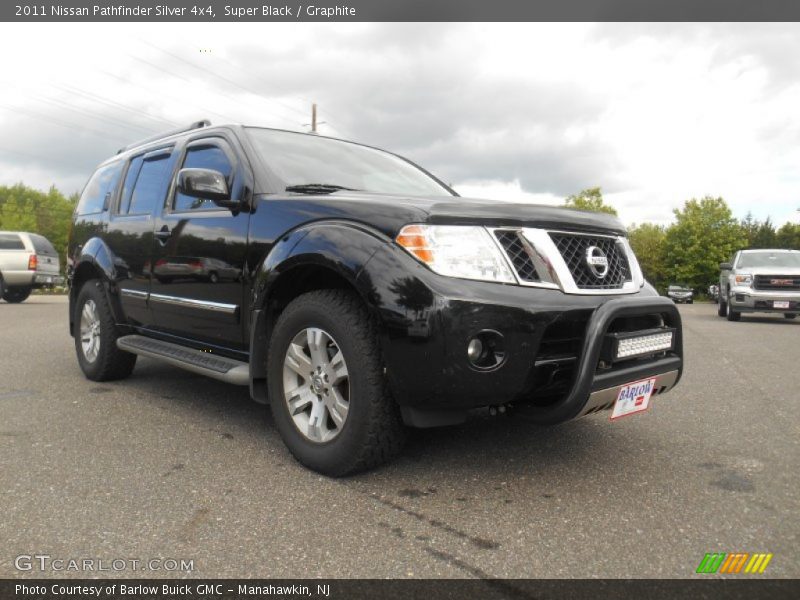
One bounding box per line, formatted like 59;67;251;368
74;279;136;381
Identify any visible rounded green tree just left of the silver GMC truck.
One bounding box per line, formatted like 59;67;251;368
664;196;747;290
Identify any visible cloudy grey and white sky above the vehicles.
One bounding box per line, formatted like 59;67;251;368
0;23;800;224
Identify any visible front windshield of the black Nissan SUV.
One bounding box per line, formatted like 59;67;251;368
247;127;452;196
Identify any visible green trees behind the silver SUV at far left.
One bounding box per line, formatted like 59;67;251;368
0;183;78;267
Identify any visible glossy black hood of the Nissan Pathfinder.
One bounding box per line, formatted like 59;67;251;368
259;192;625;237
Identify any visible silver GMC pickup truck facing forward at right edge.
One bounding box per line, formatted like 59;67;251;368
718;250;800;321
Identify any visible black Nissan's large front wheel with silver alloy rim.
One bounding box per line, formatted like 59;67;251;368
267;290;405;477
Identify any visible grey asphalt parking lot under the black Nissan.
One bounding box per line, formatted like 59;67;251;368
0;296;800;578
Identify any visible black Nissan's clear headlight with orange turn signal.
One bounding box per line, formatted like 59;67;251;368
395;225;516;283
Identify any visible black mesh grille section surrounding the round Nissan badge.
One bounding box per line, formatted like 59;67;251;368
550;232;631;290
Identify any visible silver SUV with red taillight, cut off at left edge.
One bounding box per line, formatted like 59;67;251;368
0;231;64;303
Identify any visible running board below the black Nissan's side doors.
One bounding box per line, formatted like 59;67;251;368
117;335;250;385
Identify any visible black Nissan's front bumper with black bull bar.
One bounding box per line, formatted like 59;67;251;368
360;245;683;426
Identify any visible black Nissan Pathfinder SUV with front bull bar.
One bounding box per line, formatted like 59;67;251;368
69;121;682;475
